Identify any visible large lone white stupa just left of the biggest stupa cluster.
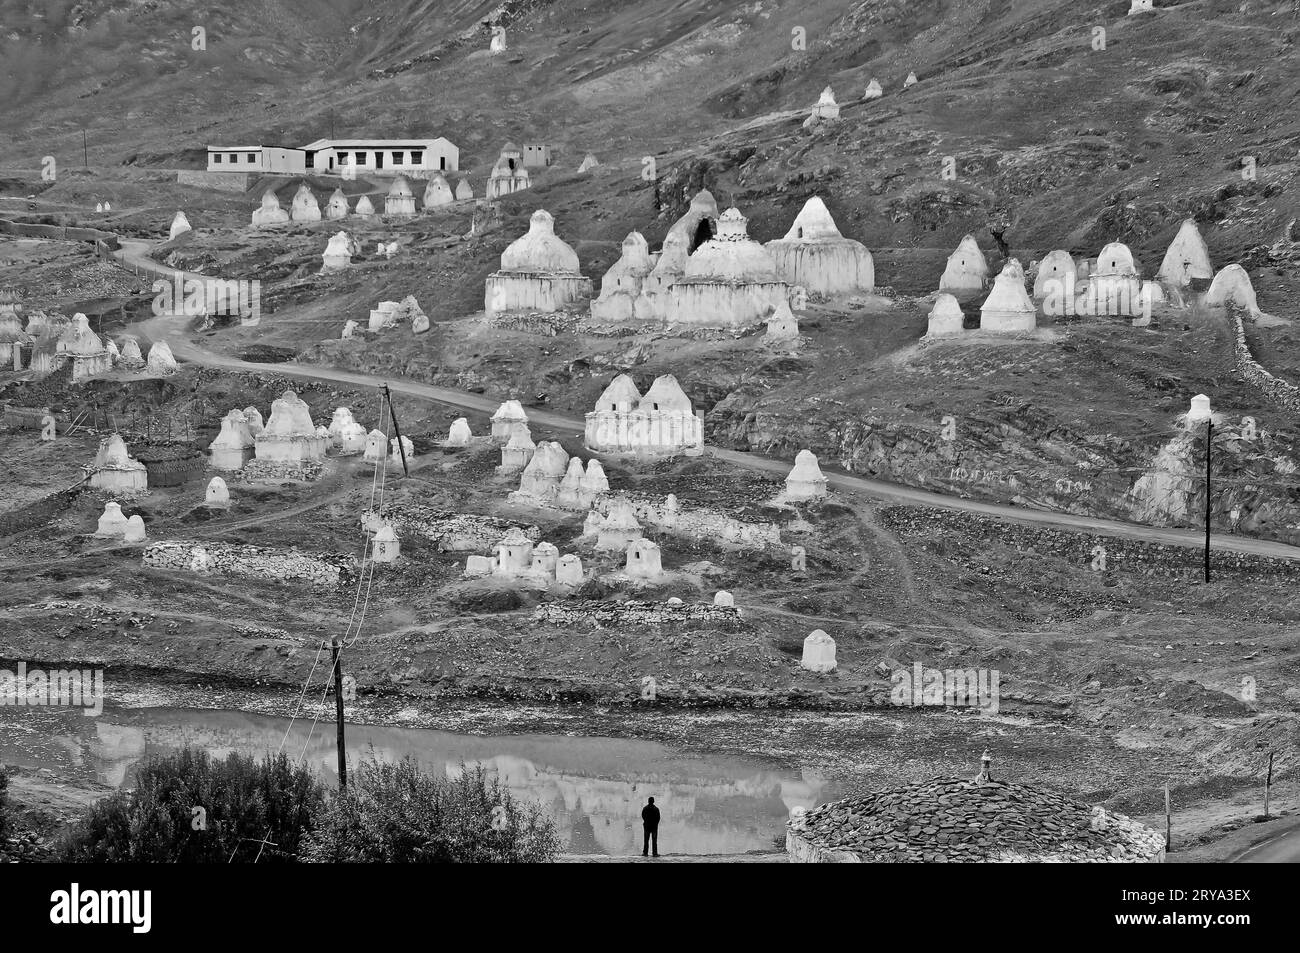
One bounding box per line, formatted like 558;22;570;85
484;210;592;315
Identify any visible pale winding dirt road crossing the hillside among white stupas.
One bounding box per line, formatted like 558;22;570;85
114;241;1300;560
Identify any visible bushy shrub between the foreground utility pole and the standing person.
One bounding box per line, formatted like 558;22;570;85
302;757;559;863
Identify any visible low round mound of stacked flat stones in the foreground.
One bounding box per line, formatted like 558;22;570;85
785;777;1165;863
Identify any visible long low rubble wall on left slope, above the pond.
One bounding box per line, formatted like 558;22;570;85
143;540;356;586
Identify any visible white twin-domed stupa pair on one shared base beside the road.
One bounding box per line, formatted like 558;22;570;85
582;374;705;456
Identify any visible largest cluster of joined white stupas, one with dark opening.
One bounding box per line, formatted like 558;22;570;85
592;191;875;328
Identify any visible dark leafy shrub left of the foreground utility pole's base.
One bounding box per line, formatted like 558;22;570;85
57;749;325;863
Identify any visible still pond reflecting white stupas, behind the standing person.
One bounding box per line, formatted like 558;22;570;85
0;709;842;854
